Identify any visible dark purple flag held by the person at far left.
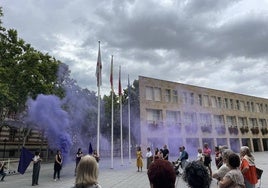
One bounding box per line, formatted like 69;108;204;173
18;147;34;174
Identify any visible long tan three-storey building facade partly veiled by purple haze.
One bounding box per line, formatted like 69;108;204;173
139;76;268;155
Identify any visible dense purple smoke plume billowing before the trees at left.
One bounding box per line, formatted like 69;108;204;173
28;94;72;159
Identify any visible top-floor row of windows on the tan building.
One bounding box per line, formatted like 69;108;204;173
145;86;268;113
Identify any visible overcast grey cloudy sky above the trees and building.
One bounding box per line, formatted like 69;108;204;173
0;0;268;98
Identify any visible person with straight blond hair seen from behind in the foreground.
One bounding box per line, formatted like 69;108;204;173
74;155;101;188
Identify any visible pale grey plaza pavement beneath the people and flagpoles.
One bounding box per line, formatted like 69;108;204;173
0;152;268;188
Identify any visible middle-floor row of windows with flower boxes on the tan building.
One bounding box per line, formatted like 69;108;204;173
146;109;267;127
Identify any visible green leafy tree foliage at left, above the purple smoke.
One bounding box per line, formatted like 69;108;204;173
0;7;63;122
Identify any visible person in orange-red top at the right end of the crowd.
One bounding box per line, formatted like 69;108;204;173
240;146;258;188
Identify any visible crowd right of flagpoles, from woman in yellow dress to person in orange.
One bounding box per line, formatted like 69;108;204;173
137;143;258;188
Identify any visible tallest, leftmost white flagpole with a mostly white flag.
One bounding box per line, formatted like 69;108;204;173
97;41;102;154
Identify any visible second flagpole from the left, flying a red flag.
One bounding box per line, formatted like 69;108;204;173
110;55;114;168
